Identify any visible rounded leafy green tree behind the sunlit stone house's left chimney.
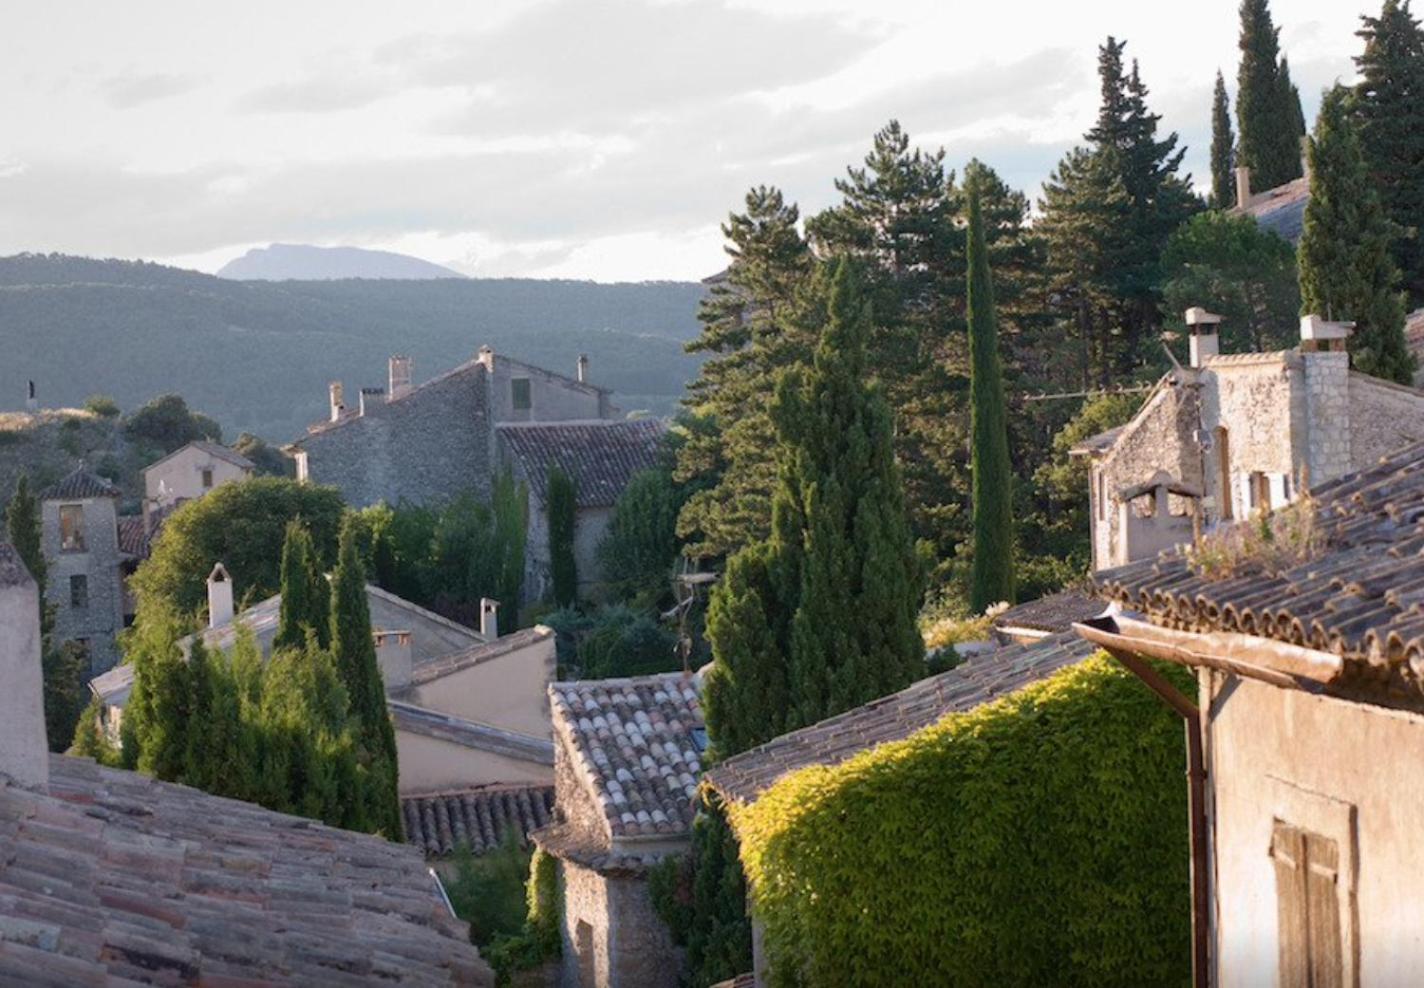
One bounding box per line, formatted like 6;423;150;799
1162;211;1300;352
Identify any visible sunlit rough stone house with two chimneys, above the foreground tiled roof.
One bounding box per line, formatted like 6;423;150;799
1072;309;1424;569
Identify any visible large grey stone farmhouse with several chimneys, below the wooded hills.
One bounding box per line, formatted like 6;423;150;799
286;355;662;598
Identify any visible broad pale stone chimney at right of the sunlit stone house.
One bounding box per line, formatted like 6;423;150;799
1300;316;1354;484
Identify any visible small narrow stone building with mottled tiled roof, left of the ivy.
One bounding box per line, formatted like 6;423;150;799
533;673;706;988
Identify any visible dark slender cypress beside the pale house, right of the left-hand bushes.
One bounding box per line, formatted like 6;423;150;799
330;515;400;840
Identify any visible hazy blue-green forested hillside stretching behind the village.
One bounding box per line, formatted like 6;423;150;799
0;255;702;441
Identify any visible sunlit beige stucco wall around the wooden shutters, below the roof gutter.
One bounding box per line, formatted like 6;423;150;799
1200;672;1424;988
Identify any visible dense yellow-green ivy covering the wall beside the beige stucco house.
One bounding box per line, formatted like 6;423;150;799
729;655;1192;988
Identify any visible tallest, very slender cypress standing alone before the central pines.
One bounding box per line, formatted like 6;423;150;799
968;185;1014;614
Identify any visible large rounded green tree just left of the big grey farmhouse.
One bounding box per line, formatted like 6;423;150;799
130;477;345;614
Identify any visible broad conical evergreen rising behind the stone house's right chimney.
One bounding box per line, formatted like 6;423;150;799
1300;85;1414;384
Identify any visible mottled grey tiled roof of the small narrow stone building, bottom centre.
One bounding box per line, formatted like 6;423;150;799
548;672;703;837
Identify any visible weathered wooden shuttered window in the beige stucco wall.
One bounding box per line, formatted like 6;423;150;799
1270;820;1344;988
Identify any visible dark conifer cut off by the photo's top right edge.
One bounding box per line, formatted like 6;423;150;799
1354;0;1424;305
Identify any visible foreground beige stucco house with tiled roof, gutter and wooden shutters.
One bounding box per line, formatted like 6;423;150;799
1079;444;1424;985
